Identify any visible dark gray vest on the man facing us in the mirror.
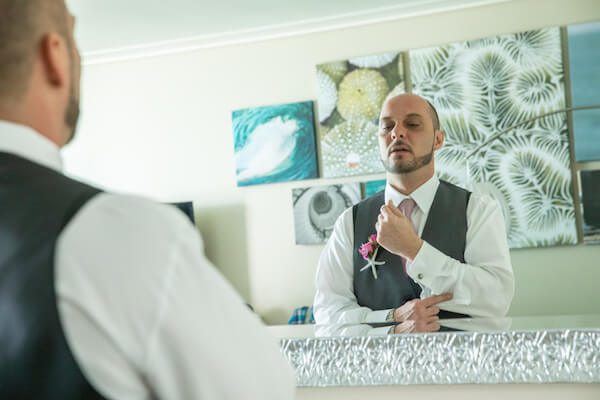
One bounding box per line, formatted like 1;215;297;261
352;181;471;318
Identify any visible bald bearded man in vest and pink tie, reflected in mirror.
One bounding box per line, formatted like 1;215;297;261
314;94;514;333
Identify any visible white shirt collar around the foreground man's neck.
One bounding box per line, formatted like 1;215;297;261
0;120;62;172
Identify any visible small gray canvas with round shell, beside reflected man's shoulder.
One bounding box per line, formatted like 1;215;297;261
292;182;361;244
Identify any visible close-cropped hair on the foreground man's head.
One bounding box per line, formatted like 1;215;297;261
0;0;70;103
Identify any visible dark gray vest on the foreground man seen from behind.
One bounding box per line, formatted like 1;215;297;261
0;152;102;400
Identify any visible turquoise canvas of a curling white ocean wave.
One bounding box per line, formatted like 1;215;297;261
232;101;319;186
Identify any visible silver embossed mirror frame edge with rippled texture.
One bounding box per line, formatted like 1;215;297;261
281;329;600;386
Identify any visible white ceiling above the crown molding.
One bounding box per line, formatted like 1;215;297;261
67;0;512;63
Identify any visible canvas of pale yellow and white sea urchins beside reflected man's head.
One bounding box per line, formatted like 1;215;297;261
317;53;405;178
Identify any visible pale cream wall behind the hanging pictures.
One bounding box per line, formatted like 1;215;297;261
64;0;600;323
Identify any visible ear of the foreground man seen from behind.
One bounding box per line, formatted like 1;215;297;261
40;32;69;87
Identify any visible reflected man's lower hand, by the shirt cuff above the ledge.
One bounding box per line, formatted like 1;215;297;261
393;293;453;333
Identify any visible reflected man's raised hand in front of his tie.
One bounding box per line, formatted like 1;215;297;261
375;200;423;261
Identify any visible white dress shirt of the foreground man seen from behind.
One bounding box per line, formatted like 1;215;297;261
0;121;295;400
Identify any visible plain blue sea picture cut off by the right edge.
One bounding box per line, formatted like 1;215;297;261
568;22;600;161
